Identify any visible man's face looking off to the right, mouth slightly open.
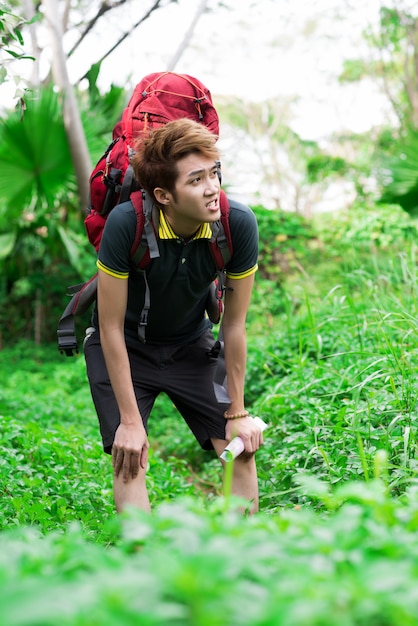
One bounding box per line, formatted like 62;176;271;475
158;154;220;236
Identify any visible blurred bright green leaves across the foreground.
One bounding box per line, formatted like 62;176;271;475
0;478;418;626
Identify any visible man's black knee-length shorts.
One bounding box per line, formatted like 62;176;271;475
84;330;229;453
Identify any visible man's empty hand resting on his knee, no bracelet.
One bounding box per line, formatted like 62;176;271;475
112;423;149;483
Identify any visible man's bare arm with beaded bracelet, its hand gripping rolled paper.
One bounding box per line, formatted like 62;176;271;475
222;274;263;453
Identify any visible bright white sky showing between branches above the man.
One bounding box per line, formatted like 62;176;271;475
0;0;392;140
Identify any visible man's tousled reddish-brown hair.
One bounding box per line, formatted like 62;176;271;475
131;118;219;200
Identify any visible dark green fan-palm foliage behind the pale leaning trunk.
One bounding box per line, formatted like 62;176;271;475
0;80;128;341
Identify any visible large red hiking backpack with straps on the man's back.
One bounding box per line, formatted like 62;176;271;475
57;72;232;356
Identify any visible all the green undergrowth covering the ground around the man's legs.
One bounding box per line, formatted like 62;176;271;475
0;238;418;626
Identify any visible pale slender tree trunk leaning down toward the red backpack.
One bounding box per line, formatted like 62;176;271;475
42;0;92;214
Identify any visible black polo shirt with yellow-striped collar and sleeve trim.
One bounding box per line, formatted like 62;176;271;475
94;200;258;344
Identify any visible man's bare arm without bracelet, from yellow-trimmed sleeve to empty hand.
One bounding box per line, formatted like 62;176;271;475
97;270;148;482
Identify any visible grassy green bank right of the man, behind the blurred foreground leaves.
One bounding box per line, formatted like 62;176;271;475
248;244;418;510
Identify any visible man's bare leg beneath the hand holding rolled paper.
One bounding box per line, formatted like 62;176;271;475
212;439;258;513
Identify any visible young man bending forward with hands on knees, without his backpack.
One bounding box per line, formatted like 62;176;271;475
84;119;262;512
